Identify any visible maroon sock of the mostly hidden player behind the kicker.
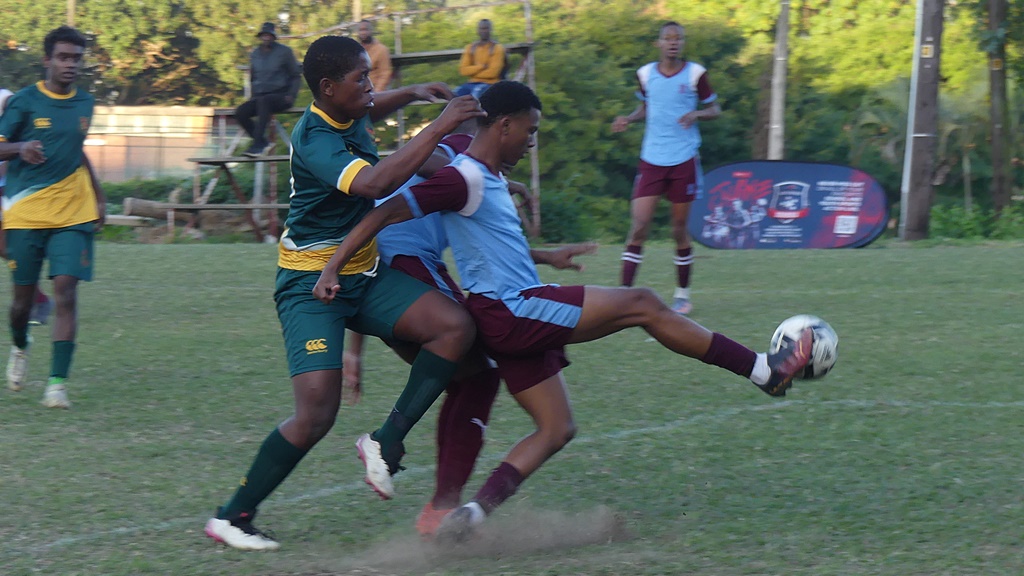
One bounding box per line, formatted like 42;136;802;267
431;368;501;508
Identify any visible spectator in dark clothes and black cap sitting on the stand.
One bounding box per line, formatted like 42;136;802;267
234;22;302;156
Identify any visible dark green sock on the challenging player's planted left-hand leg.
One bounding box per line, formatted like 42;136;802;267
218;428;308;519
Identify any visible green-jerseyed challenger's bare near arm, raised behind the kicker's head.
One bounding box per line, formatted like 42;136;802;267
349;96;485;200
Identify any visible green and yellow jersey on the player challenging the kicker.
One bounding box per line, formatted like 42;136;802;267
278;104;379;275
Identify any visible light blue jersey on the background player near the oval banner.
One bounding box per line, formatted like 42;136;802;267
637;61;718;166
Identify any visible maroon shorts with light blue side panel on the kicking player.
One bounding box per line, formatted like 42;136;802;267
466;286;584;395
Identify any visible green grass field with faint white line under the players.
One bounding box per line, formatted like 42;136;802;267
0;243;1024;576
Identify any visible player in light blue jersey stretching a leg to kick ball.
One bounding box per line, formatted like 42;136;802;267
313;81;811;538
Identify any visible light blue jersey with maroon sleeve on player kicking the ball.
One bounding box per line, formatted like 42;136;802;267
403;154;542;299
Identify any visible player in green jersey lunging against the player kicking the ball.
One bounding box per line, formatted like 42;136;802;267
206;36;483;550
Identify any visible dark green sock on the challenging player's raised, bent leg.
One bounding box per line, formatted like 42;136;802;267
373;348;459;453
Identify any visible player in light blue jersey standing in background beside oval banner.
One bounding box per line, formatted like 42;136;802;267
611;22;722;315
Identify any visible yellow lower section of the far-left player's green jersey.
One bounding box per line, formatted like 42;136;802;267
3;166;99;230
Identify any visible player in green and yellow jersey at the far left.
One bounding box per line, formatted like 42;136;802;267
0;26;106;408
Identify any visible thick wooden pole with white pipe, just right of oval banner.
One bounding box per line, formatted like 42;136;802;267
899;0;944;240
